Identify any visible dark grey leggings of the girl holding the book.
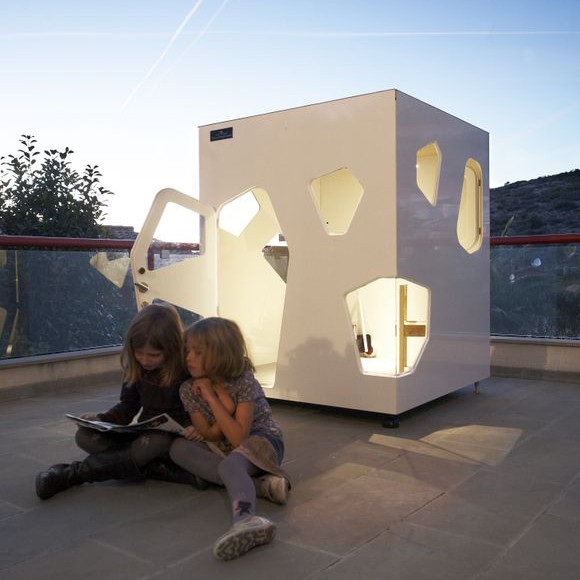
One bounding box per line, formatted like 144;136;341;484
75;427;175;467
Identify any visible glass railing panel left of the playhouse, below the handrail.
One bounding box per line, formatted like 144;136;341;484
0;250;136;358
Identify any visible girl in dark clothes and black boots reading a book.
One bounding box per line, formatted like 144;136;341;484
36;304;207;499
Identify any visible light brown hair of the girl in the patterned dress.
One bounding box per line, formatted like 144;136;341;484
185;317;254;380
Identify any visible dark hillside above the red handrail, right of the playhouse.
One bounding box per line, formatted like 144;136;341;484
490;169;580;236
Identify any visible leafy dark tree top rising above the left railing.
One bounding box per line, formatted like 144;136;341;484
0;135;111;238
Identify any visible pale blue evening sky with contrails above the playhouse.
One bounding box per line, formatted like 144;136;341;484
0;0;580;229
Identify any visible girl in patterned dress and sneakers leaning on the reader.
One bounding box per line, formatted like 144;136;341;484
170;317;290;560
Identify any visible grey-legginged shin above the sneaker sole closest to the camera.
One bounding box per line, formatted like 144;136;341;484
218;453;261;523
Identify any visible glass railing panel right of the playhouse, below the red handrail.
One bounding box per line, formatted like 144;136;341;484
491;244;580;339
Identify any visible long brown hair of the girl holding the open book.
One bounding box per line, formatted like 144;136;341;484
121;304;185;387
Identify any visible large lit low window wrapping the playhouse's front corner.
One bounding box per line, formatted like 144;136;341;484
346;278;430;376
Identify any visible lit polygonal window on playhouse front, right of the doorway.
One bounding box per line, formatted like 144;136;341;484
310;167;364;236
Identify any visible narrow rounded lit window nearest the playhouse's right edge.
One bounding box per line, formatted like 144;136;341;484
457;158;483;254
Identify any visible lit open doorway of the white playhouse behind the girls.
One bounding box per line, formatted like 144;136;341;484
217;188;288;388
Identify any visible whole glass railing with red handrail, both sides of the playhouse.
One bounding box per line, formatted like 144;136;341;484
0;234;580;359
